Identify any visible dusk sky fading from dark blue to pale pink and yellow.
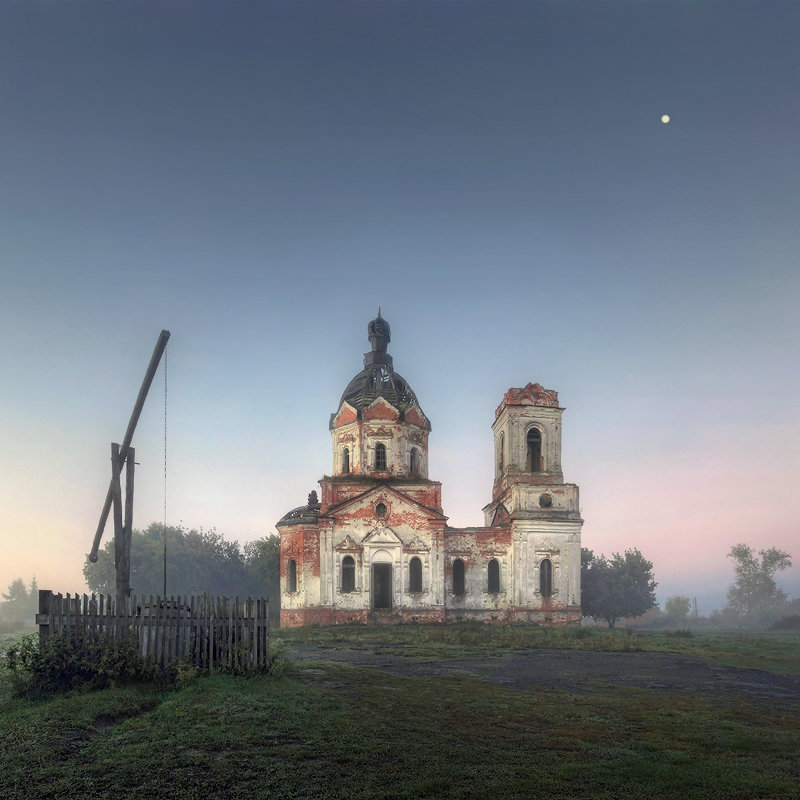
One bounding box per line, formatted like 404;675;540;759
0;0;800;613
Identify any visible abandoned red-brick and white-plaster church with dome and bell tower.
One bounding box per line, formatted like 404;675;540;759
277;313;583;626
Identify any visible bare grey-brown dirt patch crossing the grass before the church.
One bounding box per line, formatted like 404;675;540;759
287;645;800;716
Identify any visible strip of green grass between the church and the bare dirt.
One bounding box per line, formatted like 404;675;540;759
276;623;800;675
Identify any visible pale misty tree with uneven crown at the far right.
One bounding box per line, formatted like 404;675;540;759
724;544;792;623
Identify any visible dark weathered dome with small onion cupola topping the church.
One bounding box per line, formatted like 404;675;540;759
339;311;422;422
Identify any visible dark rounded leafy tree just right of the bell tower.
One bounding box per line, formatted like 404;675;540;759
581;548;657;628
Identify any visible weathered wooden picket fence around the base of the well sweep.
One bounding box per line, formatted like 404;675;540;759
36;590;269;671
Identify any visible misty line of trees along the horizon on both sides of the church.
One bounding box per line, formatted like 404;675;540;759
0;522;797;628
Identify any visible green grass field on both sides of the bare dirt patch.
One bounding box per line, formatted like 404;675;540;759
0;626;800;800
